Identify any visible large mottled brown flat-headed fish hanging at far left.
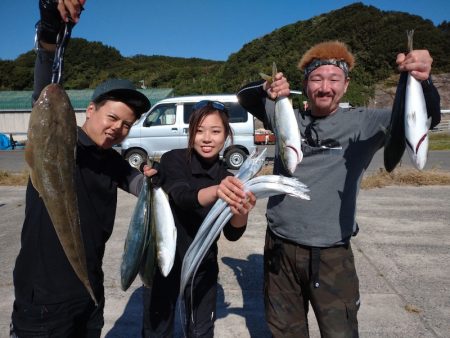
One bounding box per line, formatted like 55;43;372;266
25;84;97;304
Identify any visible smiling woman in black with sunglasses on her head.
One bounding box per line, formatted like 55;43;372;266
143;101;256;337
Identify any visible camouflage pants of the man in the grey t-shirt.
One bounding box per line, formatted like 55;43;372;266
264;230;360;338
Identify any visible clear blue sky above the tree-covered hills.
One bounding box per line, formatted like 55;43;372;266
0;0;450;60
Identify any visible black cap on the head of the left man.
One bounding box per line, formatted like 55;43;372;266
92;79;150;117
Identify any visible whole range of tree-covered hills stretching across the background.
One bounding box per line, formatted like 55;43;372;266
0;3;450;105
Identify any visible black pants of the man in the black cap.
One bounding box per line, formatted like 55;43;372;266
11;298;105;338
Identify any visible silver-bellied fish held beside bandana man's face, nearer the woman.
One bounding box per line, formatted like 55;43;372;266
260;62;303;175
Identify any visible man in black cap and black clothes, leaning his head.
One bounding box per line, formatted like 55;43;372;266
11;1;156;338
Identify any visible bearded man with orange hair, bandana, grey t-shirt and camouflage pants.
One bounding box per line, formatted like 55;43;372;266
238;41;440;337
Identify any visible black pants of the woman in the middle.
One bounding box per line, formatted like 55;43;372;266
142;255;219;338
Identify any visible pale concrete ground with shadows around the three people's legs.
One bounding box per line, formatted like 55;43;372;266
0;186;450;338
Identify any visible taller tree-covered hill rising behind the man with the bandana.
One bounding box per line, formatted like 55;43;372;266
221;3;450;104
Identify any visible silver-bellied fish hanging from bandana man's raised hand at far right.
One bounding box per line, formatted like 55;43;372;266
405;30;431;170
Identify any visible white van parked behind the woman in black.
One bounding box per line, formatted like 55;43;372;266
121;95;256;169
